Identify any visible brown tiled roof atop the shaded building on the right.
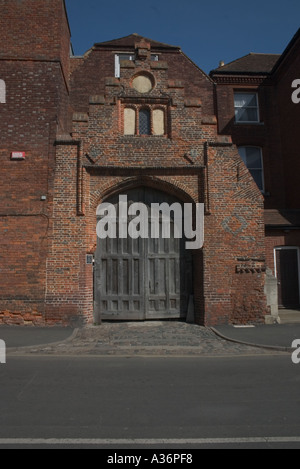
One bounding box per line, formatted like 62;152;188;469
210;52;280;75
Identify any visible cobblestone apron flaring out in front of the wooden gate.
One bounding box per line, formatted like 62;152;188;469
9;321;283;356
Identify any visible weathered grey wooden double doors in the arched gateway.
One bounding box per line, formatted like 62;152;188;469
94;187;193;322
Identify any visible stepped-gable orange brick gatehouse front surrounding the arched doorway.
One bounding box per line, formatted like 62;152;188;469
47;38;267;325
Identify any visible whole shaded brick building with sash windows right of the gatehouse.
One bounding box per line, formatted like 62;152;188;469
210;31;300;317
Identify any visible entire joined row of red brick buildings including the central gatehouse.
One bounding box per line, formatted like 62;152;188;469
0;0;300;325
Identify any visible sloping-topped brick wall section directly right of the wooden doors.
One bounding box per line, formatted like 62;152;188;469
203;146;267;324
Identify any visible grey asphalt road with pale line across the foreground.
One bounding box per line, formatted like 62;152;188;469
0;355;300;451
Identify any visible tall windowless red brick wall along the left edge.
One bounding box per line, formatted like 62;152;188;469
0;0;70;324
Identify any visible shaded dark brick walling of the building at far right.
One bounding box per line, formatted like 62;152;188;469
211;31;300;314
